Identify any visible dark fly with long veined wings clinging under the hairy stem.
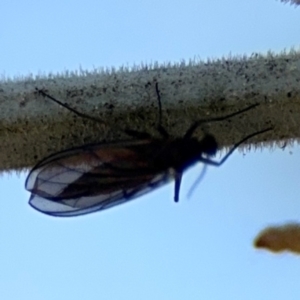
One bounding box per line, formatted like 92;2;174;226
25;84;272;217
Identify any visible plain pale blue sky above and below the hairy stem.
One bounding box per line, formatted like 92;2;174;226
0;0;300;300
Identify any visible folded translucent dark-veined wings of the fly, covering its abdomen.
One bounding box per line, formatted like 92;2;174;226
25;140;172;216
